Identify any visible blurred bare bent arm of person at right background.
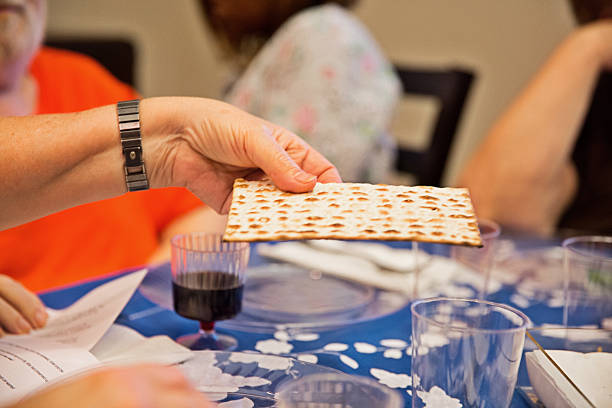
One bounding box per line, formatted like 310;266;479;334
459;20;612;235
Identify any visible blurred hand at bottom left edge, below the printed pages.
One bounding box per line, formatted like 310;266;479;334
10;365;213;408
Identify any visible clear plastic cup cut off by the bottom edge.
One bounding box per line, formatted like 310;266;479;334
278;373;404;408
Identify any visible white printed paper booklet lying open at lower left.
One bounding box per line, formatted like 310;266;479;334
0;270;192;406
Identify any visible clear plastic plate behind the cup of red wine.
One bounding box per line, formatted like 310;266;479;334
139;263;409;333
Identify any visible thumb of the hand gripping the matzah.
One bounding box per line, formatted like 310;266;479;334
251;126;317;193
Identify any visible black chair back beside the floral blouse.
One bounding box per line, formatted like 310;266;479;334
395;66;474;186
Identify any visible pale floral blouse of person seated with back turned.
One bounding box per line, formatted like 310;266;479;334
227;5;401;182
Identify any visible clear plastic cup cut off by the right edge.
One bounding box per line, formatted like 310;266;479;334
563;236;612;326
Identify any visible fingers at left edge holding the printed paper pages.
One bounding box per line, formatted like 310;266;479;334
0;275;48;337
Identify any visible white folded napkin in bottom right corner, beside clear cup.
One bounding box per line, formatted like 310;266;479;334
525;350;612;408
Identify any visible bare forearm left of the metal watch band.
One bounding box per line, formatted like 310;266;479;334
0;106;125;229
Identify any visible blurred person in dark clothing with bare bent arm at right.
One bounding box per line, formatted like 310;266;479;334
459;0;612;236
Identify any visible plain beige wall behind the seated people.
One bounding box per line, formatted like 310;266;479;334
48;0;573;183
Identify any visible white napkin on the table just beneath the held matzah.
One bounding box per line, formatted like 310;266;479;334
256;241;483;297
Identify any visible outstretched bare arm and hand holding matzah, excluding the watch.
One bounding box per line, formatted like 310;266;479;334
0;98;340;228
